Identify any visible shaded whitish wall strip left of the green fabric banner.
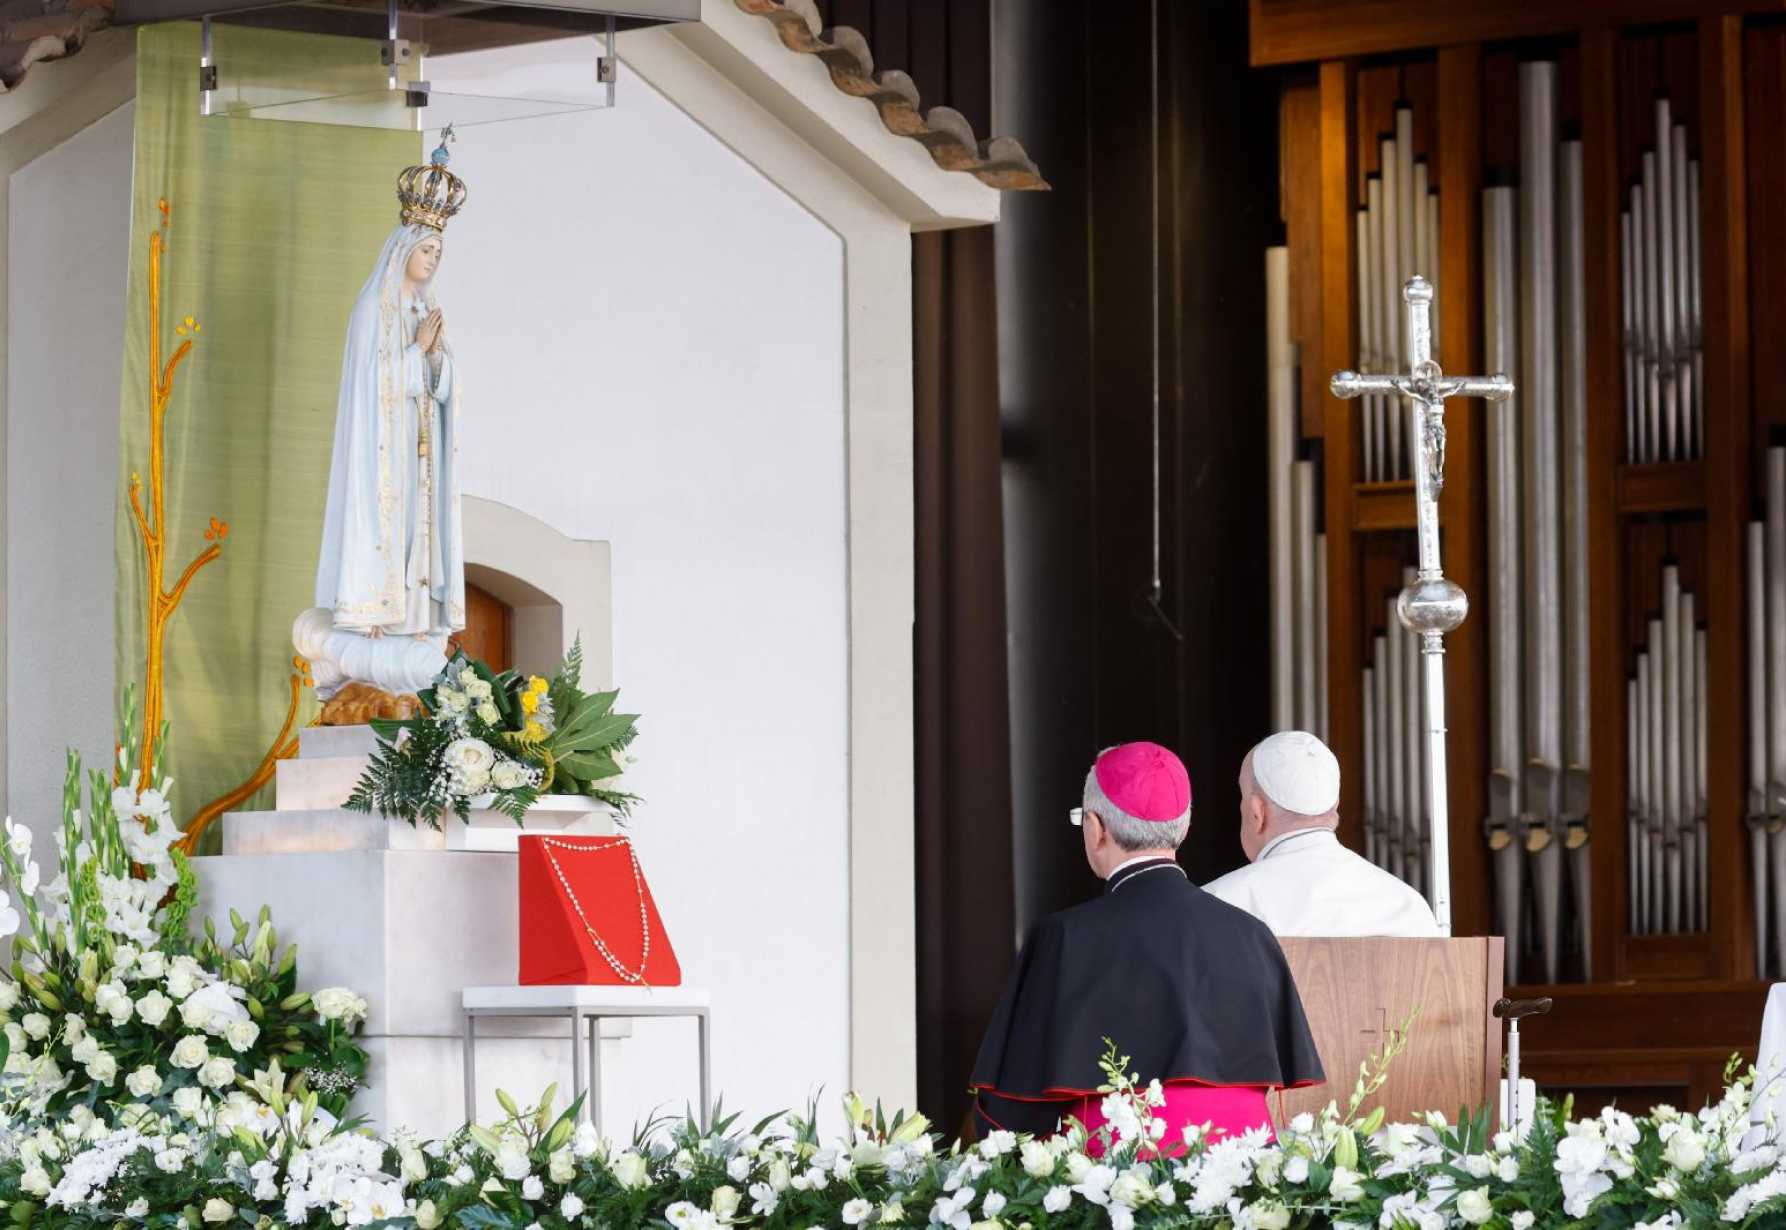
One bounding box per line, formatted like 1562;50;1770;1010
4;104;134;835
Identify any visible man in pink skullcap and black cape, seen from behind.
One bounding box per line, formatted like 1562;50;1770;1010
973;743;1323;1148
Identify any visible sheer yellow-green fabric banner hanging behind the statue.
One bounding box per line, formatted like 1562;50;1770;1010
114;23;421;835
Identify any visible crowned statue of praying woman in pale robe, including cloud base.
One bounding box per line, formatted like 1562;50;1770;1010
293;127;466;723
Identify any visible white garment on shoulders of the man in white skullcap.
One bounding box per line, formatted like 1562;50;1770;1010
1204;828;1440;935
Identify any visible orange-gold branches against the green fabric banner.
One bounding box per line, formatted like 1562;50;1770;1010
130;196;311;835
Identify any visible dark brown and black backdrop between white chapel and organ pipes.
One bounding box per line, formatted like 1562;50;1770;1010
820;0;1282;1130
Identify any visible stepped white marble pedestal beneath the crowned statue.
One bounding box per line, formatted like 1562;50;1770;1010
193;727;630;1137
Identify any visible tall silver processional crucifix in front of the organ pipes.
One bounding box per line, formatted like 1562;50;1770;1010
1331;273;1513;935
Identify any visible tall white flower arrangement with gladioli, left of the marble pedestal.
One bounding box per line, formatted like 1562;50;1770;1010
0;702;366;1119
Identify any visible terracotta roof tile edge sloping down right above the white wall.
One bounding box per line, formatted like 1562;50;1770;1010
732;0;1048;191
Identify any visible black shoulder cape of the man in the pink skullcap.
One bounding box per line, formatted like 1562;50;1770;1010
973;859;1325;1134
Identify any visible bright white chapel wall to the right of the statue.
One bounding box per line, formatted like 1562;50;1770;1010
429;41;850;1125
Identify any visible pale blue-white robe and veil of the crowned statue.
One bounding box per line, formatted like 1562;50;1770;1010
316;223;464;643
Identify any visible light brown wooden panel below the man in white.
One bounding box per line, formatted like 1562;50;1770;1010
1279;935;1506;1123
